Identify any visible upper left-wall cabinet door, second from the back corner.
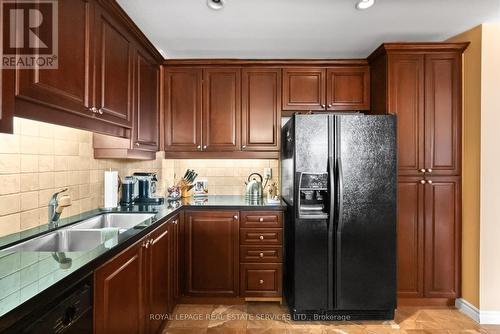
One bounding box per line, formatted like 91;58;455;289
95;5;133;128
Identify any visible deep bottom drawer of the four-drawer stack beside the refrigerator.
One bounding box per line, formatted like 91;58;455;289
240;263;283;297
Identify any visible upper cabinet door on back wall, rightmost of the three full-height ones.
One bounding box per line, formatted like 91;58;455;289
241;68;281;151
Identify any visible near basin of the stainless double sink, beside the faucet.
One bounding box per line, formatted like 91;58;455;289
5;229;118;252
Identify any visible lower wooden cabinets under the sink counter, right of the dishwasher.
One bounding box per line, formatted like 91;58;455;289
94;216;179;334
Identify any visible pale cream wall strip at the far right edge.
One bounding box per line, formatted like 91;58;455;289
480;24;500;312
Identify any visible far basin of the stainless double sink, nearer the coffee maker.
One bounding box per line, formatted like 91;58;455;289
71;213;155;232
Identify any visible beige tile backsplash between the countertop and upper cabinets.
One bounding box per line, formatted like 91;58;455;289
0;118;279;236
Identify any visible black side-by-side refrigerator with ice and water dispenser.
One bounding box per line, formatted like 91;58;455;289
281;114;397;321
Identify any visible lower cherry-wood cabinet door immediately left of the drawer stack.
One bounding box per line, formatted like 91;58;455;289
185;210;239;297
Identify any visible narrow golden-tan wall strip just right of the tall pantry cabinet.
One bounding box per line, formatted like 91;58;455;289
449;26;482;307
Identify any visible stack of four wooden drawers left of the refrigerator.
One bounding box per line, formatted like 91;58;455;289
240;211;283;298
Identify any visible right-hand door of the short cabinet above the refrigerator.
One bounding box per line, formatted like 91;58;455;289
326;66;370;110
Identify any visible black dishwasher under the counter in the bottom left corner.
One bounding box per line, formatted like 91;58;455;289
7;275;93;334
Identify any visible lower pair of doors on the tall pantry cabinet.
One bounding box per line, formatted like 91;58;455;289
398;176;461;299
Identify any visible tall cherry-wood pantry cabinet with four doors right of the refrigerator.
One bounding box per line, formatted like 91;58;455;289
369;43;468;304
